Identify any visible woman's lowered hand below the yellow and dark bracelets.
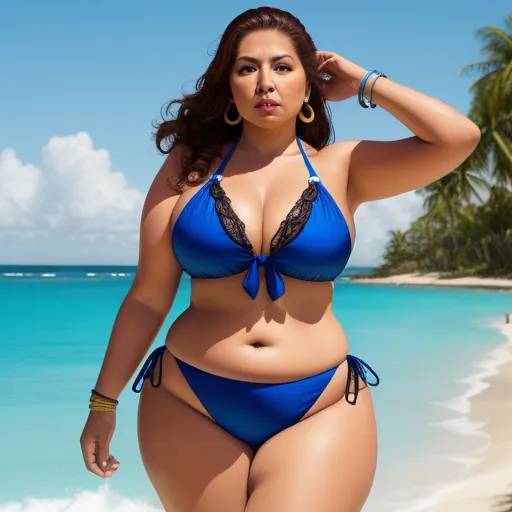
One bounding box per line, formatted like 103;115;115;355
80;411;119;478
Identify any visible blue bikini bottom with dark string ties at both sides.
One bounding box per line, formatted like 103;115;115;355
132;345;379;451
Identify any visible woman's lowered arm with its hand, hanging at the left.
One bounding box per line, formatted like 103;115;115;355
80;146;182;477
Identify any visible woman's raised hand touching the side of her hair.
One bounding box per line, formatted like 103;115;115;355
316;51;367;101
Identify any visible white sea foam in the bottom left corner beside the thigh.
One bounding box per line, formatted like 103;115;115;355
0;484;163;512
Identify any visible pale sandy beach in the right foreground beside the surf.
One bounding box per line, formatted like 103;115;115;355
415;323;512;512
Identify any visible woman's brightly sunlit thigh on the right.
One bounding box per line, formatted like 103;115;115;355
246;388;377;512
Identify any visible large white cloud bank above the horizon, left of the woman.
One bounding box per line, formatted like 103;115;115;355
0;132;144;264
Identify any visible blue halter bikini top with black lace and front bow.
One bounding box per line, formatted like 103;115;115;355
171;137;352;301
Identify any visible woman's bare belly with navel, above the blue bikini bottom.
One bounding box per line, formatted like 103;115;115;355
166;290;348;382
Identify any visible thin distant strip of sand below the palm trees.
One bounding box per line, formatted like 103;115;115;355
350;272;512;289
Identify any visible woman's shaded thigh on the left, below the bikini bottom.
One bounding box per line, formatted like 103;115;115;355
138;383;252;512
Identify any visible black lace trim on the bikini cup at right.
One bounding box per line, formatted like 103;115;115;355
270;181;318;253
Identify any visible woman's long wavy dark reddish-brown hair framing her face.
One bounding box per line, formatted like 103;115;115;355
153;7;332;190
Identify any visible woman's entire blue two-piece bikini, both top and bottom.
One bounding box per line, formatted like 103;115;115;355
132;137;379;450
